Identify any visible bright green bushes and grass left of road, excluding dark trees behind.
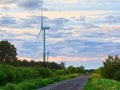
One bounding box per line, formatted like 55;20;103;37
0;65;84;90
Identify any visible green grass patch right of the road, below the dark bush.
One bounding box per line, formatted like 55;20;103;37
84;77;120;90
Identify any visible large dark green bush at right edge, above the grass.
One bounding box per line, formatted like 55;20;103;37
101;55;120;81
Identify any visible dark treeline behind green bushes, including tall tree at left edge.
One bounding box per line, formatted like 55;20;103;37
0;41;64;69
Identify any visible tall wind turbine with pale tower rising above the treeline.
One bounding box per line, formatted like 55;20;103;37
37;5;49;62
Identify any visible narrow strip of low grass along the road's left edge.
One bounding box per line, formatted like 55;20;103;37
4;74;79;90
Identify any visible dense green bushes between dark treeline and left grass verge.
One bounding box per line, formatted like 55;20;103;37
0;65;52;85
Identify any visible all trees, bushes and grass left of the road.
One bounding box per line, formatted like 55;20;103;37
0;41;86;90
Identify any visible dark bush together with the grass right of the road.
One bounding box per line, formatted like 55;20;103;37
84;55;120;90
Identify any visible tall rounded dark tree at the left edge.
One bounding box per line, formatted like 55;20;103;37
0;41;17;64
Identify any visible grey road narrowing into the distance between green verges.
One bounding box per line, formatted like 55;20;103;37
37;75;89;90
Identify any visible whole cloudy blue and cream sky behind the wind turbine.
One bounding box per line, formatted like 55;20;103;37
0;0;120;69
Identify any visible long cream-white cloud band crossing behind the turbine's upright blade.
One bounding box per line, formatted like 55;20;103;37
3;10;115;19
